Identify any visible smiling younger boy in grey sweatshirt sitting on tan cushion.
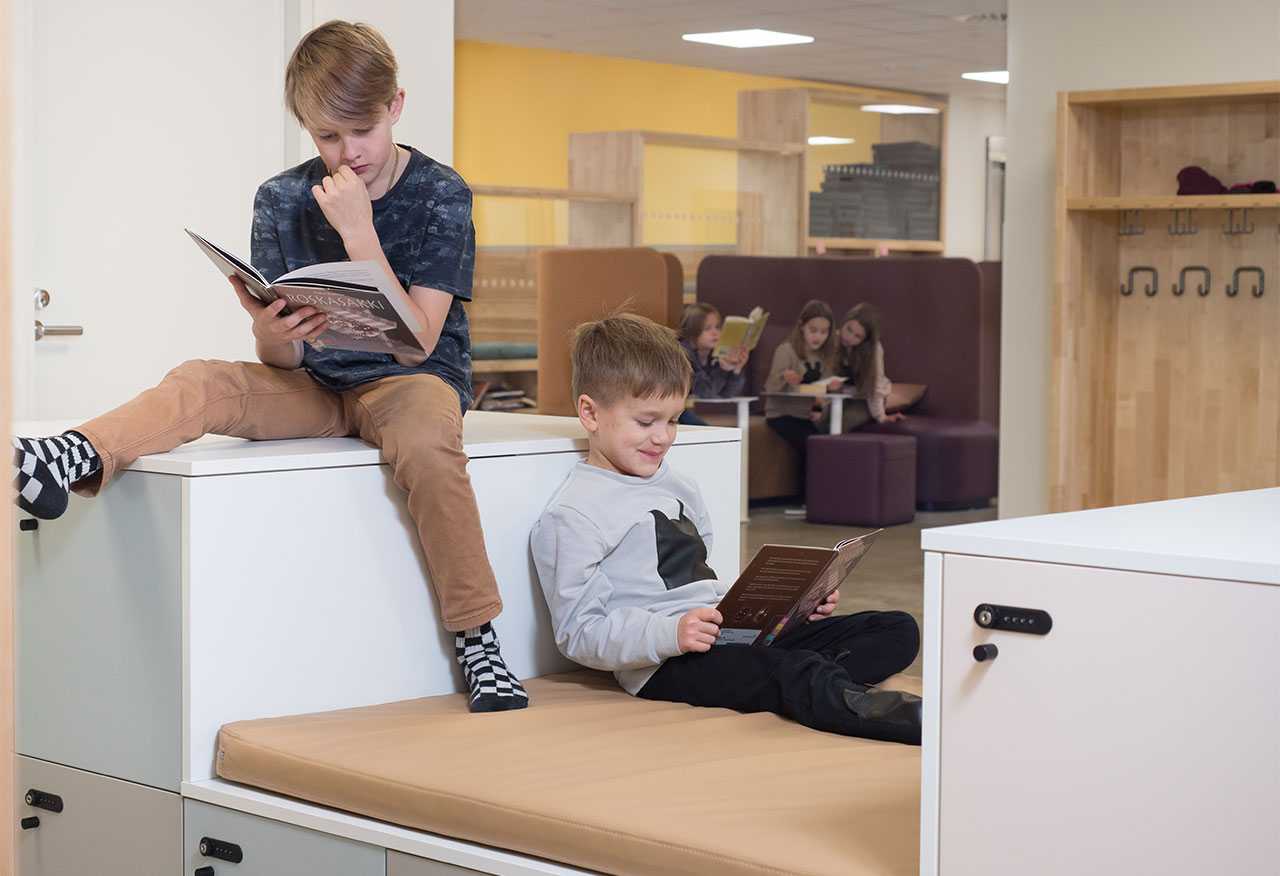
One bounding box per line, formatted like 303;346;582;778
530;315;920;744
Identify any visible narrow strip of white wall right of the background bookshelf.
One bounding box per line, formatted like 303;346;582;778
945;96;1005;261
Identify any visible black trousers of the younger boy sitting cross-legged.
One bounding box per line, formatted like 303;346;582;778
639;611;920;736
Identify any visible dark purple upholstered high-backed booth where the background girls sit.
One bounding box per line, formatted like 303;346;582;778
698;256;1000;508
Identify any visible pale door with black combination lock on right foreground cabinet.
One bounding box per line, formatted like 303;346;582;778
938;555;1280;876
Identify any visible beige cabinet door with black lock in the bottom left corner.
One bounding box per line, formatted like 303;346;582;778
14;757;182;876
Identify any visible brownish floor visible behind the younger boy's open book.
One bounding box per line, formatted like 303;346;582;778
742;506;996;675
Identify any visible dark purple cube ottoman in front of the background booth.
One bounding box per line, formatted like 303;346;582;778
805;432;915;526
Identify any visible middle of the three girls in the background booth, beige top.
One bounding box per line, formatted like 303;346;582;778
764;300;845;484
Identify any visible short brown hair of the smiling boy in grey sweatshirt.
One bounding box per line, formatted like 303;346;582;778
570;314;694;405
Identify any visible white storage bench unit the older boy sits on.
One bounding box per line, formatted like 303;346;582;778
15;412;740;876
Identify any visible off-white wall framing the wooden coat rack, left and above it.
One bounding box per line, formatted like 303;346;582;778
1003;0;1280;517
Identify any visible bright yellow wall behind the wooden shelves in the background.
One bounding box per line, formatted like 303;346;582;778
453;40;926;246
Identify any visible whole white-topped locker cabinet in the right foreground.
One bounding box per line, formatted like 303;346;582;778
920;489;1280;876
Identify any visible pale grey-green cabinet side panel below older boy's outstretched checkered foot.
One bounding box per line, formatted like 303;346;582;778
14;471;182;791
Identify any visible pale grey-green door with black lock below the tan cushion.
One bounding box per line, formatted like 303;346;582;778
182;800;387;876
